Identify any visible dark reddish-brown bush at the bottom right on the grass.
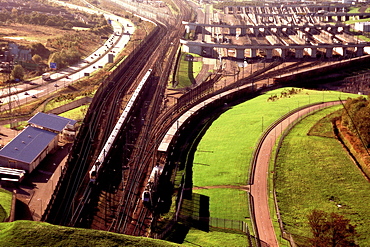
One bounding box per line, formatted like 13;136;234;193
308;210;359;247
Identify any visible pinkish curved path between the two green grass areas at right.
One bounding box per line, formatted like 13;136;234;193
250;101;340;247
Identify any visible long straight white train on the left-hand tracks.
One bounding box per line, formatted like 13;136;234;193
89;69;152;184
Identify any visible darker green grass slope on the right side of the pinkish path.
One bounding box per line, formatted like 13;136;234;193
277;105;370;247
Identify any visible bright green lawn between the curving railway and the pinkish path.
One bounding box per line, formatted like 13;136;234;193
184;89;353;246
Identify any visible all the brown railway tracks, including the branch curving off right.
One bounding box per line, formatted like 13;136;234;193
43;2;364;243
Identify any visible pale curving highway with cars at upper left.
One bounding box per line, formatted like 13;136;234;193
0;1;135;111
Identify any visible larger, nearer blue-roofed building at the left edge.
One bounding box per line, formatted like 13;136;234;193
0;126;58;173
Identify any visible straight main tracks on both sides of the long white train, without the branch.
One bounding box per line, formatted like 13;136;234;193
44;0;192;235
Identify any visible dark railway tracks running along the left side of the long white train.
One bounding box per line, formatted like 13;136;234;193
44;23;160;226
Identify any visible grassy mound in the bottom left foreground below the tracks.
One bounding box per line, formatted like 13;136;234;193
0;221;178;247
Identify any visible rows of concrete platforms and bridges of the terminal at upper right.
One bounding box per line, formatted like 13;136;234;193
181;5;370;59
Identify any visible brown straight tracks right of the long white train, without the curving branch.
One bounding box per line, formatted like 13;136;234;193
102;1;192;236
